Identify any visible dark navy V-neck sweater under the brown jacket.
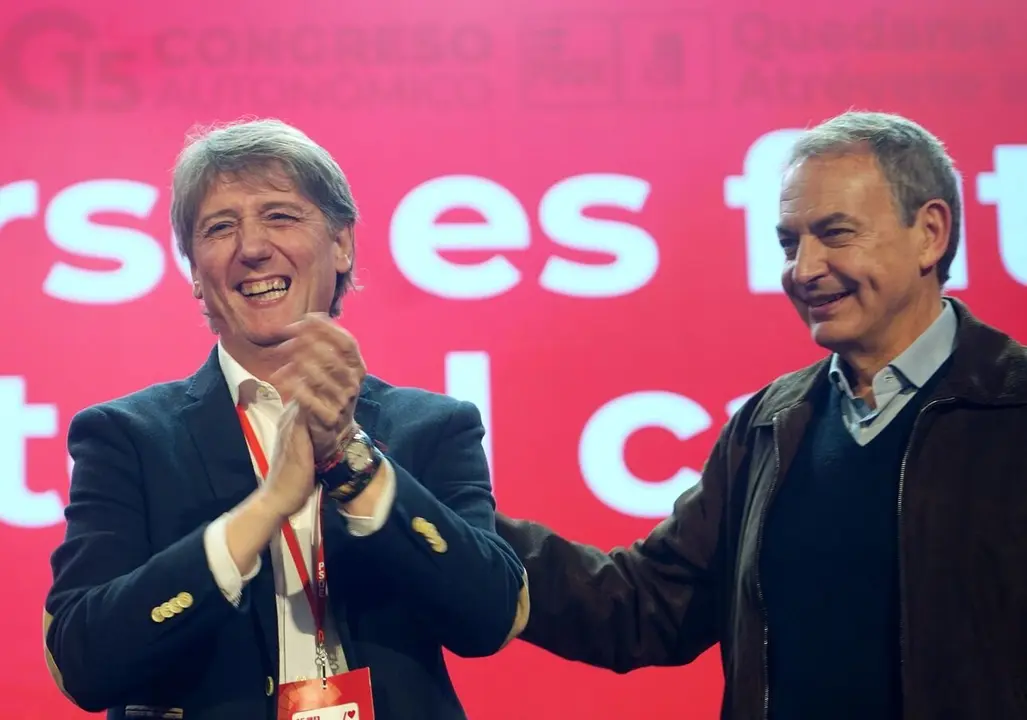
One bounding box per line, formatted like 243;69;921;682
760;366;947;720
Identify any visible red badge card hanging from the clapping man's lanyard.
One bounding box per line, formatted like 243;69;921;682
278;668;375;720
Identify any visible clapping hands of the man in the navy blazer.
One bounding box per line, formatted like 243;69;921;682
266;313;367;518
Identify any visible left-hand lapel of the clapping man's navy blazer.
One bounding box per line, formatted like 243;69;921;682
183;346;278;677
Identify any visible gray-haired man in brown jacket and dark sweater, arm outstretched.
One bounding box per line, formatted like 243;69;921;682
498;112;1027;720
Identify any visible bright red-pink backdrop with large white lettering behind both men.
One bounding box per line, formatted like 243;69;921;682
0;0;1027;720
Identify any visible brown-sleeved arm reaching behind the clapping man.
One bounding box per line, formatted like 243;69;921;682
497;427;727;673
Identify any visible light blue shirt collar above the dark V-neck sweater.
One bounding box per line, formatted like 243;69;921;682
828;300;958;445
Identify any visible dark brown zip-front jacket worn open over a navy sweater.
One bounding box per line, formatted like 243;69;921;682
498;301;1027;720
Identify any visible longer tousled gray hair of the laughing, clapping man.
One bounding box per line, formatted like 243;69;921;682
172;119;358;316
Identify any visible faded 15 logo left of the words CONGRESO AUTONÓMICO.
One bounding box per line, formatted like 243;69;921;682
0;8;142;113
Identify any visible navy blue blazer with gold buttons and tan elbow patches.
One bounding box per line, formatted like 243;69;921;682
43;348;528;720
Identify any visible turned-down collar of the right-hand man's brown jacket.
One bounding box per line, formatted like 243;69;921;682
753;297;1027;426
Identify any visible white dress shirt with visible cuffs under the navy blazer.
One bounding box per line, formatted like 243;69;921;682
203;343;395;683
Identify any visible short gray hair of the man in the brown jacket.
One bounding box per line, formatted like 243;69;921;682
788;111;962;285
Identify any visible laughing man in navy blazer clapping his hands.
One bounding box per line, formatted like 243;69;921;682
44;120;528;720
